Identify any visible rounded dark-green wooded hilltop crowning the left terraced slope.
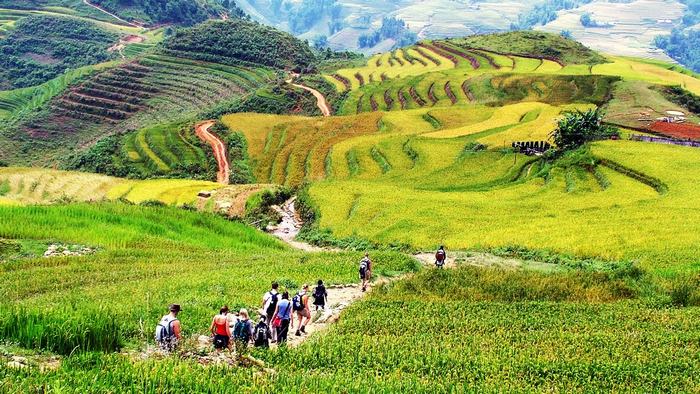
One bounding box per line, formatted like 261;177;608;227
163;18;314;70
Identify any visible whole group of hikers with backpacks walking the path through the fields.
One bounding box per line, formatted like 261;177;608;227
155;246;447;353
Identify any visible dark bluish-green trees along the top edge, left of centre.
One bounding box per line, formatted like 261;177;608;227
92;0;221;26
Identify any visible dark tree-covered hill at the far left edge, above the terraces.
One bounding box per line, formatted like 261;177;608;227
0;15;119;89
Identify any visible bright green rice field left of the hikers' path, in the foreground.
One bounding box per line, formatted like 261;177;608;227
0;204;416;355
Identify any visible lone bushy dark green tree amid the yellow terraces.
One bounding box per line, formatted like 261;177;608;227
552;109;620;151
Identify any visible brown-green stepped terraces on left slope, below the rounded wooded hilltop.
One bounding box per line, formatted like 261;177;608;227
12;54;277;164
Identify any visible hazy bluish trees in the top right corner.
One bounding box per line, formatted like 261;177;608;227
654;0;700;72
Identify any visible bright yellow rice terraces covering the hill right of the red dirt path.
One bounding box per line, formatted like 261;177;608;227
217;33;700;271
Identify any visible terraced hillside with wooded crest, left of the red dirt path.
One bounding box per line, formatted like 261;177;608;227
0;15;322;168
